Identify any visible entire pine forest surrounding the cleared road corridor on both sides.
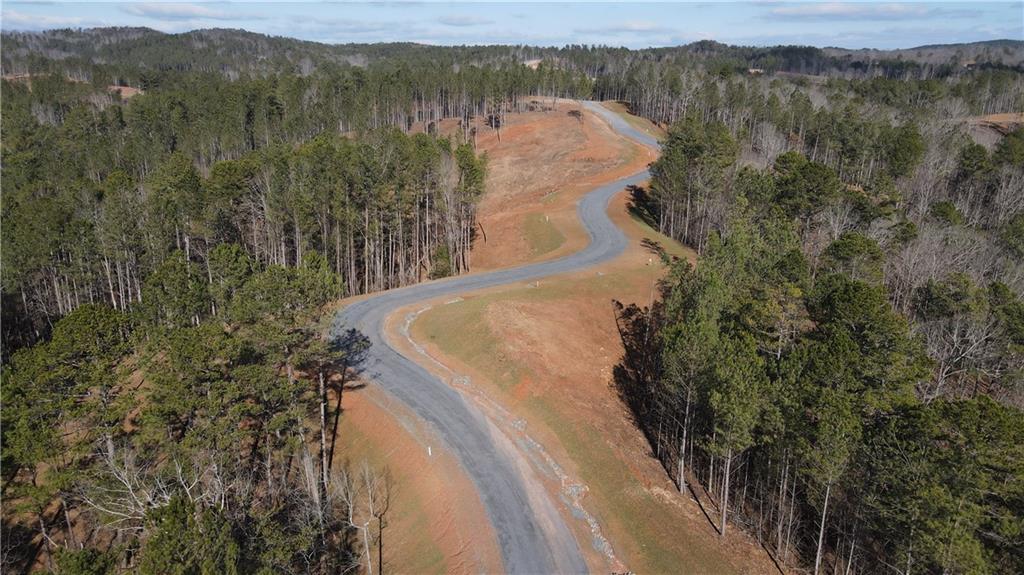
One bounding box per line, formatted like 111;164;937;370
0;29;1024;573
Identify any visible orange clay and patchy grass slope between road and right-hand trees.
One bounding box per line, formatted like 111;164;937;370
399;189;775;573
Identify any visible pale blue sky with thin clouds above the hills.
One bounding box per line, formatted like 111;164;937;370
0;0;1024;48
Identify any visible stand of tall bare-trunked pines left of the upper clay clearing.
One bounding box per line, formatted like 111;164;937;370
3;118;485;344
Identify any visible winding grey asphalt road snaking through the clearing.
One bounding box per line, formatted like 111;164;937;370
331;102;658;574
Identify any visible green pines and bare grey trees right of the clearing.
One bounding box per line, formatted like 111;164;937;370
616;106;1024;573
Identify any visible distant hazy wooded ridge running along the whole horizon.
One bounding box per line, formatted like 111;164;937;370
0;27;1024;78
